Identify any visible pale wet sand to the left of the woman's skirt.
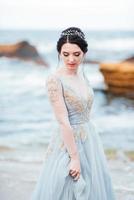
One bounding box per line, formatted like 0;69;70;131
0;161;41;200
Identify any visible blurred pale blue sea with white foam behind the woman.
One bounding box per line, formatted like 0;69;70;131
0;30;134;162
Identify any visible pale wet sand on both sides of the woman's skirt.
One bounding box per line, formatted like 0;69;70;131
0;151;134;200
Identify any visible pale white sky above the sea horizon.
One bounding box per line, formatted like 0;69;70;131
0;0;134;30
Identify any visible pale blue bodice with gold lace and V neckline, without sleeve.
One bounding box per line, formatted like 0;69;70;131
61;78;94;124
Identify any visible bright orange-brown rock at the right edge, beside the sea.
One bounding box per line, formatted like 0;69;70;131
100;62;134;97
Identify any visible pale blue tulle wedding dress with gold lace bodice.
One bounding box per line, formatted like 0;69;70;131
32;77;115;200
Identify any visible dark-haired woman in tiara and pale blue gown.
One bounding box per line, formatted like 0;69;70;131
32;27;115;200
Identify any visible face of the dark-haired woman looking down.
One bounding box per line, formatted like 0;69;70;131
60;43;84;70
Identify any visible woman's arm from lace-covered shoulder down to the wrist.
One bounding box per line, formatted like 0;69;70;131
46;75;78;158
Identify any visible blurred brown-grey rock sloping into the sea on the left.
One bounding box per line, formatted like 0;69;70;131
0;41;48;66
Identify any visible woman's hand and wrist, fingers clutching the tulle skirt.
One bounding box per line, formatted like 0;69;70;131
69;158;80;180
